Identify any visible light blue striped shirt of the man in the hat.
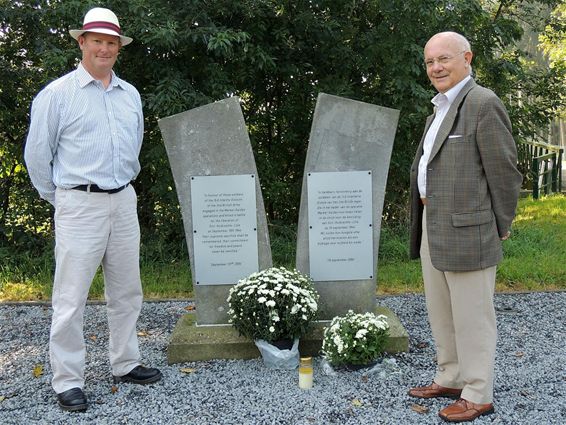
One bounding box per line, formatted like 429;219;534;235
24;60;143;205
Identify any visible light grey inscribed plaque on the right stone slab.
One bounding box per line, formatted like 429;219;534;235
307;171;374;281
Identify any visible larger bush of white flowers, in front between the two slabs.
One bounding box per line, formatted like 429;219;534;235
227;267;319;342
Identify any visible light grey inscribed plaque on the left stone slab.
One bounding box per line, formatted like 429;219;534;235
191;174;259;285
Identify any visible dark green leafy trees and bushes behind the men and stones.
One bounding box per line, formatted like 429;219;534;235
0;0;566;272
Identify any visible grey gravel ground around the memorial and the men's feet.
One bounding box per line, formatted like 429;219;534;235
0;292;566;424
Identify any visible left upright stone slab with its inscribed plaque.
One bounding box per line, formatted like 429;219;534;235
159;97;272;325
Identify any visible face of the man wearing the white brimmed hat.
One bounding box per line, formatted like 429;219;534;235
79;32;121;78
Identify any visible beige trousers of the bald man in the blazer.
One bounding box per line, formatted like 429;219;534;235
420;207;497;404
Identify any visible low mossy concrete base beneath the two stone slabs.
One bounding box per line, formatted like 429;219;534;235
167;307;409;364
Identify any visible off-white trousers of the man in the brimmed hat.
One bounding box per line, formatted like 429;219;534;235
49;185;143;393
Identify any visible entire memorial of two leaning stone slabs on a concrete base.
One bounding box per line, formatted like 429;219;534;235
159;95;408;363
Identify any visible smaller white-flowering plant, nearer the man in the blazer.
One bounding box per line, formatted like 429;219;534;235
322;310;389;369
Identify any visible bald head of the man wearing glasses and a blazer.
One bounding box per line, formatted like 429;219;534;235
424;35;472;93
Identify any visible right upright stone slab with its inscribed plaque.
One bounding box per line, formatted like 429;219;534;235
296;93;399;320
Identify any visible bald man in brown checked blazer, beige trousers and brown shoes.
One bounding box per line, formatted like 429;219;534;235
409;32;522;422
